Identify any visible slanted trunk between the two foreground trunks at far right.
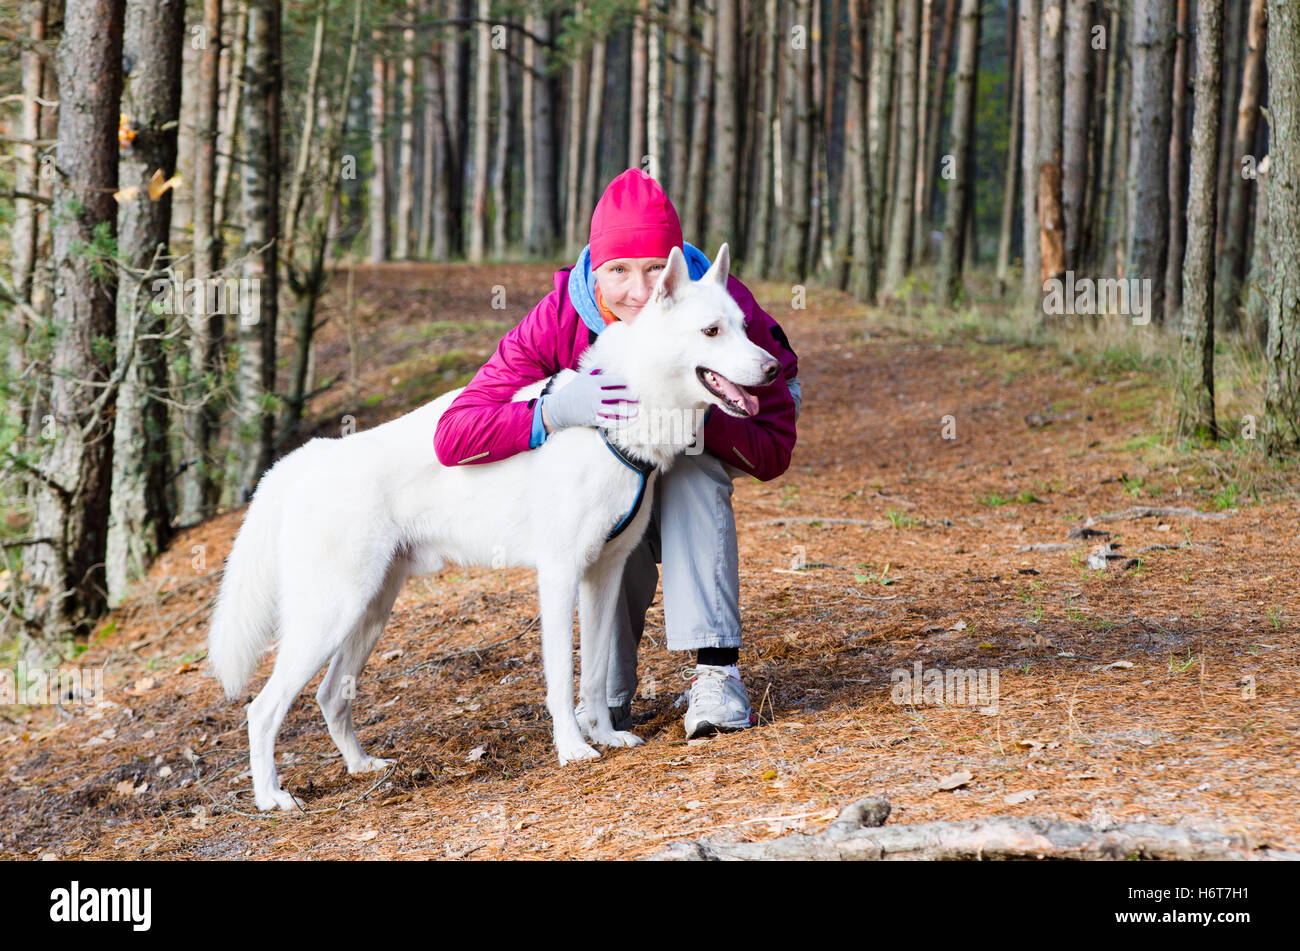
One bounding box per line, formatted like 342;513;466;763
1214;0;1271;330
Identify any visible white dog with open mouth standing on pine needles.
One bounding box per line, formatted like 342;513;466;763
208;244;779;809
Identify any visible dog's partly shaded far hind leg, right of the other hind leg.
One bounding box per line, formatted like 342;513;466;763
316;559;407;773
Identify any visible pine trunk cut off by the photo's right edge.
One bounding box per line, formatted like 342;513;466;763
1264;0;1300;459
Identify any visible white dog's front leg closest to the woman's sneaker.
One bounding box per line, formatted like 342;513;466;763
577;553;645;746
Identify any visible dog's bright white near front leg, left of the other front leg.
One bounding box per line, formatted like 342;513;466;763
537;564;598;764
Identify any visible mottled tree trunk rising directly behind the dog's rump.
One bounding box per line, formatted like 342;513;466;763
231;0;280;504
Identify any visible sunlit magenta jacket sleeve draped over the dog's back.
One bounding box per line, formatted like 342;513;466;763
433;291;562;465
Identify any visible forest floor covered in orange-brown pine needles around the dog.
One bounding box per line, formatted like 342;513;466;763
0;265;1300;859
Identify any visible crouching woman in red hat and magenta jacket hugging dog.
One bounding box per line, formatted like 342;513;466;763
434;169;800;738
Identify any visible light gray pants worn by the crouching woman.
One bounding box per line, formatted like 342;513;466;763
606;381;801;707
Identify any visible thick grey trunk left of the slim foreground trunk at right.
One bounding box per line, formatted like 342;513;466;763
1125;0;1174;321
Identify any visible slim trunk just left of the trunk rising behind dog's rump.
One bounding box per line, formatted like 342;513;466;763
177;0;225;526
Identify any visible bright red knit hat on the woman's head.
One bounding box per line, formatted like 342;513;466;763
590;169;681;270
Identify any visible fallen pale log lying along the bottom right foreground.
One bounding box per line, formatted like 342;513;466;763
650;799;1300;861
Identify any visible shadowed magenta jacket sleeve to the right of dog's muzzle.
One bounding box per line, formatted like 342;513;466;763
705;278;798;482
